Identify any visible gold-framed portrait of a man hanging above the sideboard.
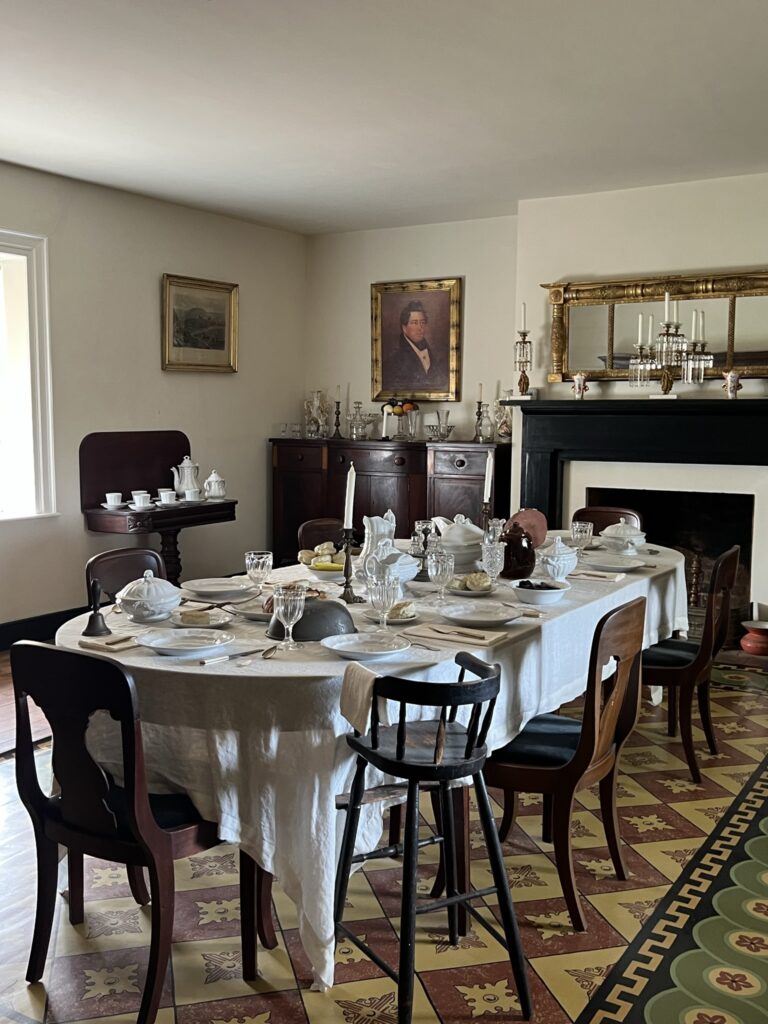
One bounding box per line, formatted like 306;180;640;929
371;278;462;401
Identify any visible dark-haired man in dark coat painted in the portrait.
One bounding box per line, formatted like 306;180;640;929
382;299;449;394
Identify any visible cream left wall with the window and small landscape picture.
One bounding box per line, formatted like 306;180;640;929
0;164;306;623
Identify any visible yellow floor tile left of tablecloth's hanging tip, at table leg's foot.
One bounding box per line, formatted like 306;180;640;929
171;936;296;1006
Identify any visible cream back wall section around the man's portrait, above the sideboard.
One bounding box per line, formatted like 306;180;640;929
304;217;516;438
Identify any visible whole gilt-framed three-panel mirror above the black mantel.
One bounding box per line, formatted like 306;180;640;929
542;269;768;383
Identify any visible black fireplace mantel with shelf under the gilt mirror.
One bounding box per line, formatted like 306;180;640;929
505;398;768;527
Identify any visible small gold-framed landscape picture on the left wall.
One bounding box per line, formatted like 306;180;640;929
163;273;238;373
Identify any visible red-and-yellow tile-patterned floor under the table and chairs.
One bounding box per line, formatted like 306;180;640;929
0;689;768;1024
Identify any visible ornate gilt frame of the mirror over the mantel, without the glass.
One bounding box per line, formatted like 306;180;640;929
541;269;768;384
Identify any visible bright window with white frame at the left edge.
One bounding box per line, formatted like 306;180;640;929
0;230;55;520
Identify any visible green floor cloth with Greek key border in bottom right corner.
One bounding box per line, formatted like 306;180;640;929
578;757;768;1024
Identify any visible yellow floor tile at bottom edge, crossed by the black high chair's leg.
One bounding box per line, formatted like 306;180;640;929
303;978;439;1024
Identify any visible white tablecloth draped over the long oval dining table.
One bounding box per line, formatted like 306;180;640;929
55;546;688;988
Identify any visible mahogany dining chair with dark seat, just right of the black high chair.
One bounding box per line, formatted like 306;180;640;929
482;597;645;932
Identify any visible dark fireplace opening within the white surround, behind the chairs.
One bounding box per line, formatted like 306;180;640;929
585;487;755;646
